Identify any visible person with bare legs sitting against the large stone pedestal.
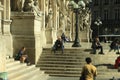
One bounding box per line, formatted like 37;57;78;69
15;47;30;65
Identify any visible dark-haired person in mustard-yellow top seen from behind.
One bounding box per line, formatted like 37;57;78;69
80;57;97;80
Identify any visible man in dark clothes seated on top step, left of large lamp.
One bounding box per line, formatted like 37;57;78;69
53;37;64;53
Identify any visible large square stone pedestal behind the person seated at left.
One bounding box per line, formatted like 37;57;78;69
11;12;45;63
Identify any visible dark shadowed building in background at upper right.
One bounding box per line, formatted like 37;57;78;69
91;0;120;35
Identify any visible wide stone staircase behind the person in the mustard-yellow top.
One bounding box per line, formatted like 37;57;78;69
36;48;120;80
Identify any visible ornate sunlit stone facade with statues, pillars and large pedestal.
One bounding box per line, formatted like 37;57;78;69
0;0;90;71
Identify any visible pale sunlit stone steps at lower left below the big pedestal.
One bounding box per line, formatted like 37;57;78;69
6;58;48;80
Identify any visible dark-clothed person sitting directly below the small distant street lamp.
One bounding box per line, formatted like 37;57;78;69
92;37;104;54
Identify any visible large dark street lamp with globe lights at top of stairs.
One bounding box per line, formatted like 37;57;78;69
68;0;85;47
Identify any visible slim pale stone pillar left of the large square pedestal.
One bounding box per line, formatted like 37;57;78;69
2;0;13;57
